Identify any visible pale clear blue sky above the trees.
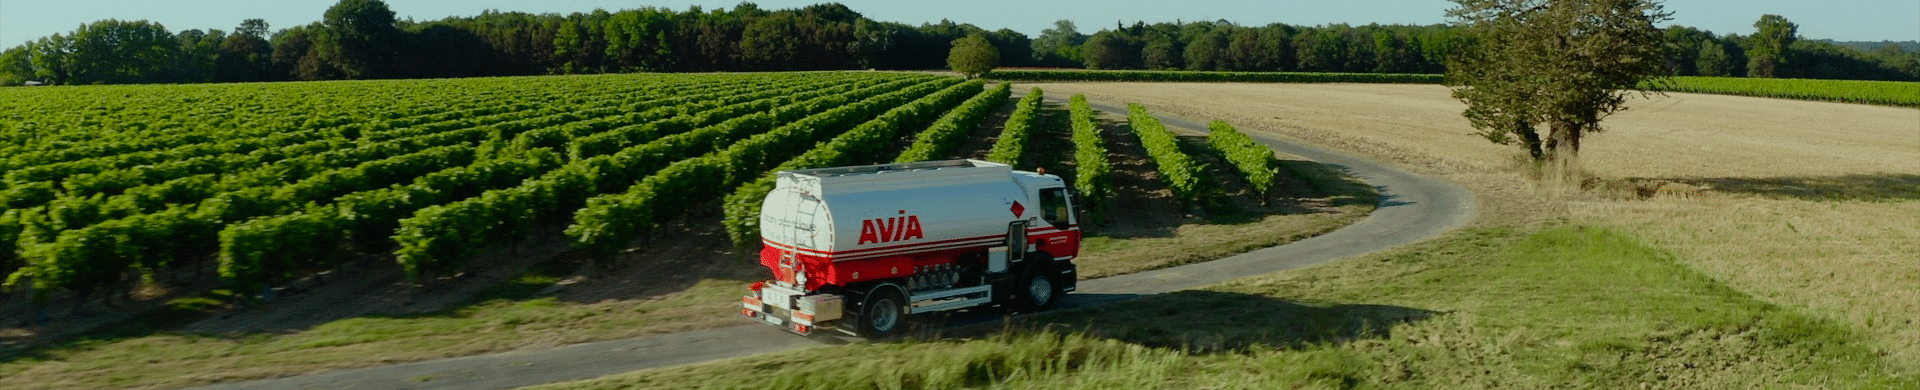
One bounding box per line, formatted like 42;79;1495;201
0;0;1920;48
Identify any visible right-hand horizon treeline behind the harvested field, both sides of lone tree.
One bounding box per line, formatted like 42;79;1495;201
1059;15;1920;81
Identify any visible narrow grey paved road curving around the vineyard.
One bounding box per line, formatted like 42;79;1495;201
183;92;1475;390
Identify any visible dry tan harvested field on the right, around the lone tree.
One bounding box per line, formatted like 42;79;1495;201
1018;83;1920;367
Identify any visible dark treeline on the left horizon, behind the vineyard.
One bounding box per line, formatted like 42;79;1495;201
0;0;1031;85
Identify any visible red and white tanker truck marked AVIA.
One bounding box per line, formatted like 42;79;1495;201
741;159;1081;338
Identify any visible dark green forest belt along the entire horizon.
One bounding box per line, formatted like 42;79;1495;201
0;0;1920;85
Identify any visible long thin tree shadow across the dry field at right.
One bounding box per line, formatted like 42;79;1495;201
1605;173;1920;202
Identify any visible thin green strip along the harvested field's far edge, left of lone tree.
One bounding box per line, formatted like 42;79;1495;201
991;71;1442;85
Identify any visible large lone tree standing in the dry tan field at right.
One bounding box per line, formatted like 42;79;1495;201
1446;0;1672;163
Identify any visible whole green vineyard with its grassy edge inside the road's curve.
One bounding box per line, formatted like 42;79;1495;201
0;73;1373;388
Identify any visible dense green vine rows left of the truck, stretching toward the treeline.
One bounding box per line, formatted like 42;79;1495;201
0;73;1008;298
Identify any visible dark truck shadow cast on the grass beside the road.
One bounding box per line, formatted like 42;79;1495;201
908;290;1440;353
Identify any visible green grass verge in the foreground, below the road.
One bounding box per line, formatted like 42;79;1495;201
518;225;1916;390
